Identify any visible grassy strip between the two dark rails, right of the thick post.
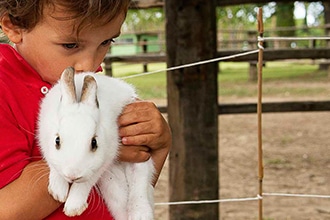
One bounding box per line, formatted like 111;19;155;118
218;61;328;97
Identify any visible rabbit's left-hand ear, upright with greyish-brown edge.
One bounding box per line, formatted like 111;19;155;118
60;67;77;104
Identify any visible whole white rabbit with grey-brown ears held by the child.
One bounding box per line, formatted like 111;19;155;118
37;68;154;220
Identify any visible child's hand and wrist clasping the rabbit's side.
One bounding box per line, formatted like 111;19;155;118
118;101;172;184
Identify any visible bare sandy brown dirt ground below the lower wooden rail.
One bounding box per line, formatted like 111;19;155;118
151;85;330;220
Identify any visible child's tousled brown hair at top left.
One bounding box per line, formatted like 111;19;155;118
0;0;130;32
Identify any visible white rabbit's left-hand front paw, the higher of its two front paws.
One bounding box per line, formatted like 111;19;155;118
48;176;69;202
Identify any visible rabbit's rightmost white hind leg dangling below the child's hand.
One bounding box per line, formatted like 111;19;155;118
126;159;154;220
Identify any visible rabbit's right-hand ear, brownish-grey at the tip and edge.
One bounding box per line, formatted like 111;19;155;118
81;75;99;108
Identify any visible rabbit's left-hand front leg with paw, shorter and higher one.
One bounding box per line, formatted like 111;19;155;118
48;168;70;202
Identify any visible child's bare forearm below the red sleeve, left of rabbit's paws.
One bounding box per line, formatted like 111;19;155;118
0;160;61;220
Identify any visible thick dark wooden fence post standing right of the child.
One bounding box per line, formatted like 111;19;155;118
165;0;219;220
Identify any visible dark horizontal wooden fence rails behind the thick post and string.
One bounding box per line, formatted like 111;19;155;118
104;26;330;114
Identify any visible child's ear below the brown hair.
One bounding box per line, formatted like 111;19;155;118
1;15;23;44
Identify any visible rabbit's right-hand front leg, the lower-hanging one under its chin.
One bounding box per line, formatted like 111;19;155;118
64;181;93;217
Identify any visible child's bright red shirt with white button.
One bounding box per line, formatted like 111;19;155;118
0;44;113;220
